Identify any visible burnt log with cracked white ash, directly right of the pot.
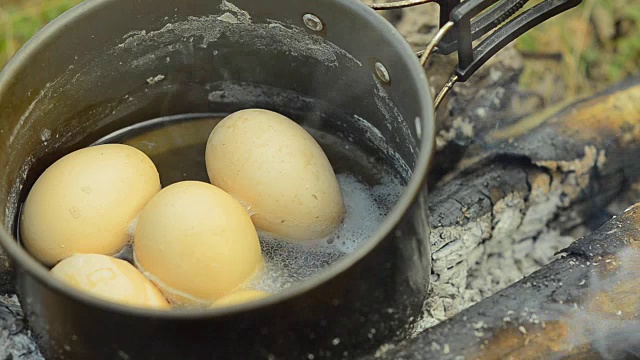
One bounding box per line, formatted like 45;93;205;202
416;78;640;333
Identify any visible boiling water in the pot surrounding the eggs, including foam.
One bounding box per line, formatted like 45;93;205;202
38;114;404;293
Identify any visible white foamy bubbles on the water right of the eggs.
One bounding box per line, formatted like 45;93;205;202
251;174;402;293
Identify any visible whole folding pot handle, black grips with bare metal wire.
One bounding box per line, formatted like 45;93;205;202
371;0;582;110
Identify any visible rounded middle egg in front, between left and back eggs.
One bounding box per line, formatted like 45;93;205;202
133;181;263;307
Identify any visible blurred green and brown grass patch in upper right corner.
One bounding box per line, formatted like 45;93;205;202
517;0;640;97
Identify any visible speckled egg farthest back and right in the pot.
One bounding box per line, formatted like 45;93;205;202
206;109;345;241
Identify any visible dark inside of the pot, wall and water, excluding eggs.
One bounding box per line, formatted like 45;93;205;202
0;0;433;356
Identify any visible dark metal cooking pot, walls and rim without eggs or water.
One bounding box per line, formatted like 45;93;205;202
0;0;434;359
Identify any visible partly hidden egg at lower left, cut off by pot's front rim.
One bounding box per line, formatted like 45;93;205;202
50;254;169;309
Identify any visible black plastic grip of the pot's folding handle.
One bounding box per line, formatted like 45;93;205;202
437;0;582;82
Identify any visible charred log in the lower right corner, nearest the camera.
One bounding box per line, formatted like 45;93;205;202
378;204;640;360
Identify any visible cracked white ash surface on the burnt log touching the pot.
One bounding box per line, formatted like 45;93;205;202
414;148;601;335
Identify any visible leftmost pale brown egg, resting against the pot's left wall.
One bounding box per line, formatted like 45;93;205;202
20;144;160;266
